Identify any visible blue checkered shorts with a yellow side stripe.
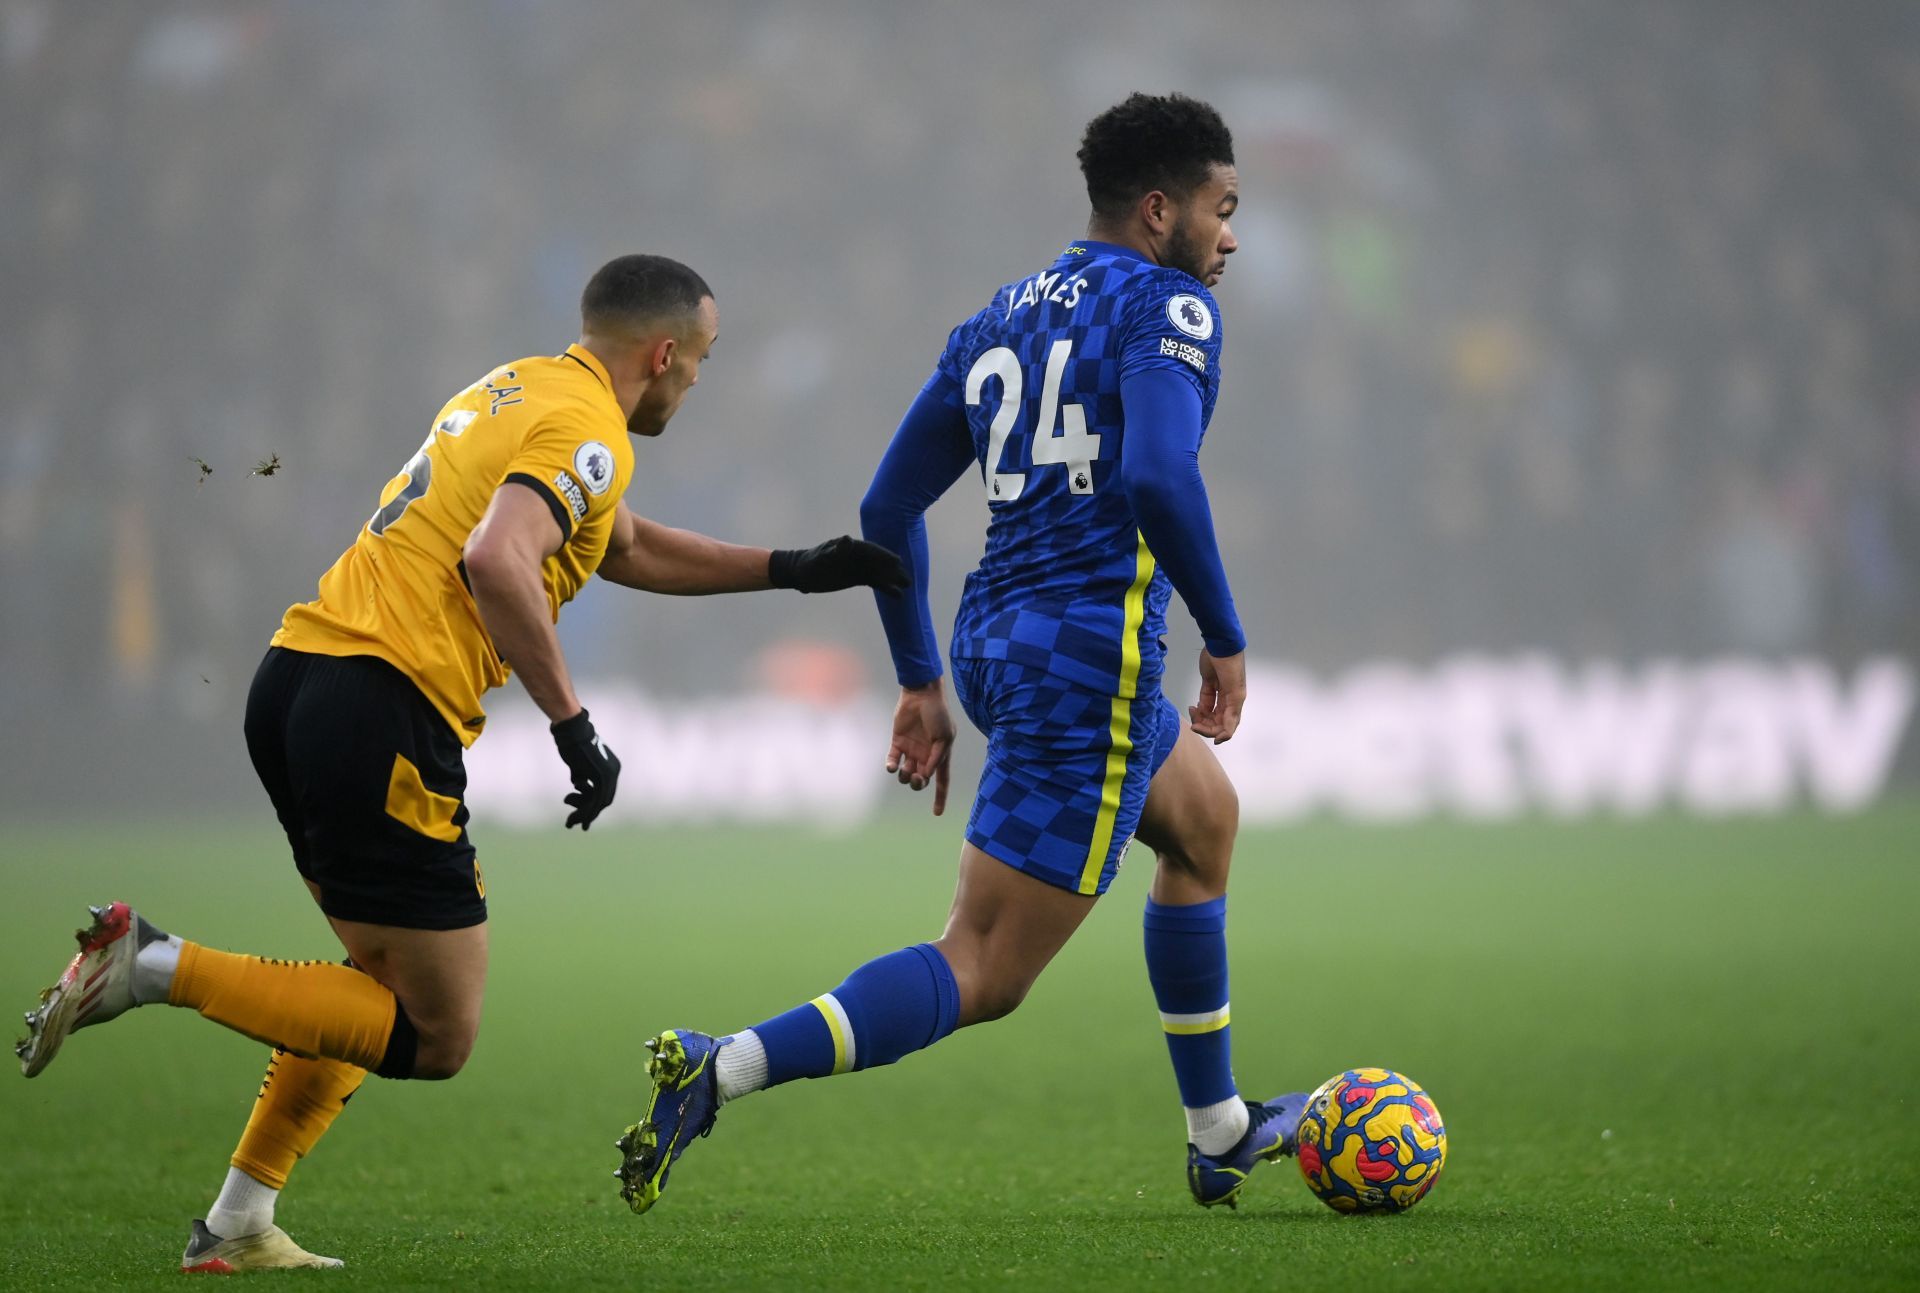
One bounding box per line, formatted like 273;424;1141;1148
954;659;1181;893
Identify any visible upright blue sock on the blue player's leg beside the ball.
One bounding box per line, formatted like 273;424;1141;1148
1144;895;1236;1109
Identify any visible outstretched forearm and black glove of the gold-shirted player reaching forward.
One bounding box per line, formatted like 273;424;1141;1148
597;503;906;598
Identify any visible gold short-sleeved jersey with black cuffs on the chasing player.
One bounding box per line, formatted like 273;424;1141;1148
273;346;634;745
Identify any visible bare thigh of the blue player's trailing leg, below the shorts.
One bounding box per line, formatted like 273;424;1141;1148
935;843;1096;1026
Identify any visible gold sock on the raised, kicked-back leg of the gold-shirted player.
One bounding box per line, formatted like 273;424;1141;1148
167;943;395;1068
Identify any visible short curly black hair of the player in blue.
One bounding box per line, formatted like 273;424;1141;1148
1079;92;1233;217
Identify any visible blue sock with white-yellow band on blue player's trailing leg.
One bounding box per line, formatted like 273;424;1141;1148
753;943;960;1086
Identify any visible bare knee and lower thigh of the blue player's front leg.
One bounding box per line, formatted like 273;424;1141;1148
1135;724;1240;907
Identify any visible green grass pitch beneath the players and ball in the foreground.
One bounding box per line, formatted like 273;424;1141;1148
0;805;1920;1291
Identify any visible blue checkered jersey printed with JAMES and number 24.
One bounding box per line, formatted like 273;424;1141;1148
937;242;1221;688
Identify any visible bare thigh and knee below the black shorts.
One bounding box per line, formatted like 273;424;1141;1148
330;918;488;1078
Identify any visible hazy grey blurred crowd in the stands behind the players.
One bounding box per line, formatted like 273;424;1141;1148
0;0;1920;776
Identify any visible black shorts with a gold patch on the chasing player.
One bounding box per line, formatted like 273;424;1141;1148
246;647;486;930
